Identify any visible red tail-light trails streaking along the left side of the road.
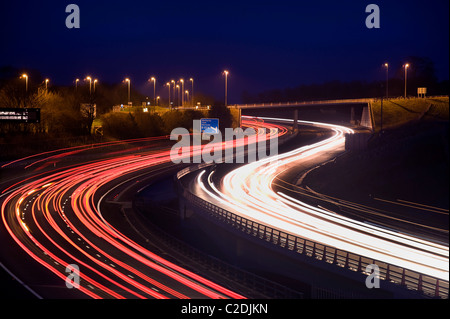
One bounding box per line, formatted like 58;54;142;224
1;120;286;299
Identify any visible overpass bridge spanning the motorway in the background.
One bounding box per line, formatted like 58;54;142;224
227;98;376;131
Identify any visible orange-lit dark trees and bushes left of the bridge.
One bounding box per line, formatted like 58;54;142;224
0;67;233;161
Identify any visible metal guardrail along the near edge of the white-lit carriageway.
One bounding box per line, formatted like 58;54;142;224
177;178;449;299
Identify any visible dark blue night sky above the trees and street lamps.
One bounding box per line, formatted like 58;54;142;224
0;0;449;103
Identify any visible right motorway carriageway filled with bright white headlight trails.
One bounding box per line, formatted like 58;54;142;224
190;118;449;281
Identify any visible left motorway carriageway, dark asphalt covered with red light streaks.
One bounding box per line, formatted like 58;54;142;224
0;120;286;299
